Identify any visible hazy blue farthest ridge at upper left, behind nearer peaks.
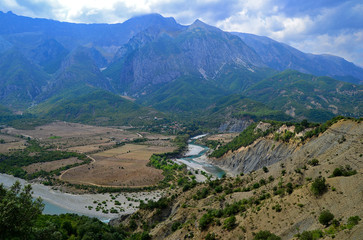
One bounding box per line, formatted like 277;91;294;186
0;11;180;60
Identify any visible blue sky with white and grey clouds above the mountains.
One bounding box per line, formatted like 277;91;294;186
0;0;363;67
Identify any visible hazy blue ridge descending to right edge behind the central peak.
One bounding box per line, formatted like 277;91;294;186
234;33;363;84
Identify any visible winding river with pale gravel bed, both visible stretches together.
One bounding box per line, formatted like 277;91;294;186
0;135;225;219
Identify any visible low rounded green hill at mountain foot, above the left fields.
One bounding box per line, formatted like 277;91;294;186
29;86;163;125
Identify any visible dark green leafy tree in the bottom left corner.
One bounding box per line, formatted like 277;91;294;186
0;181;44;239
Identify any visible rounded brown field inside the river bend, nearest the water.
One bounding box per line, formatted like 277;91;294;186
61;144;175;187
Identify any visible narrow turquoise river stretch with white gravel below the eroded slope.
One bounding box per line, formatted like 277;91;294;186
175;134;226;178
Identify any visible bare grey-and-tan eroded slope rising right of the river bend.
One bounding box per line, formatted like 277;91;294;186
211;121;363;174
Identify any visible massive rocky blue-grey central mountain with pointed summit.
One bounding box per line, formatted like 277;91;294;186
105;20;263;95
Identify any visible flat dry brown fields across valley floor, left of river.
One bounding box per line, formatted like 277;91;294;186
0;121;175;187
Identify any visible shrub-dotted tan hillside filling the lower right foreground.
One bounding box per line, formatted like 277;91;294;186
113;120;363;240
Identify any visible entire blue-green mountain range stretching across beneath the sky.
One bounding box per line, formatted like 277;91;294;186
0;12;363;126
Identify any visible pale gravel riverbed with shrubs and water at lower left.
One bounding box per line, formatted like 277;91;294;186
0;174;164;221
